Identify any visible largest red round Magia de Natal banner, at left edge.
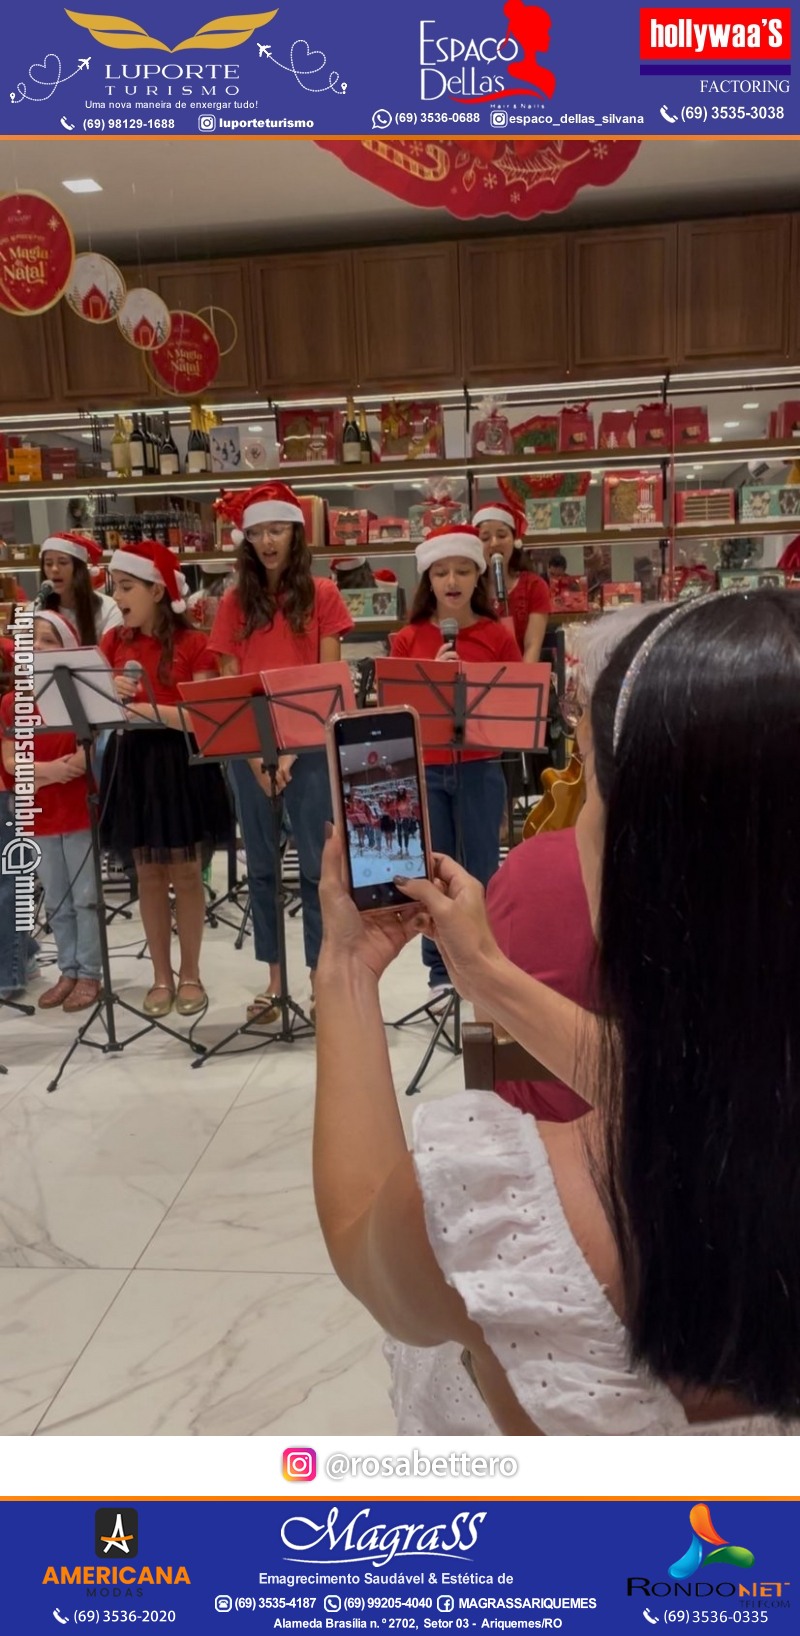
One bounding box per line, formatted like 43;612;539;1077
0;193;75;317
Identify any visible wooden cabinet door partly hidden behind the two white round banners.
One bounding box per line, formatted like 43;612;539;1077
54;267;152;409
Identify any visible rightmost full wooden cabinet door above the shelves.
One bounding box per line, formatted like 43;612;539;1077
677;216;792;366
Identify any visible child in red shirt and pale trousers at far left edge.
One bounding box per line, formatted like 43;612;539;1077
0;610;101;1011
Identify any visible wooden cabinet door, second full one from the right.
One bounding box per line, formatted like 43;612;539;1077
569;224;676;376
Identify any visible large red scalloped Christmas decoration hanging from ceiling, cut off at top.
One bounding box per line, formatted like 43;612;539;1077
316;137;640;221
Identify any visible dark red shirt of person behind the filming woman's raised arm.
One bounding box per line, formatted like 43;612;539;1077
486;829;597;1124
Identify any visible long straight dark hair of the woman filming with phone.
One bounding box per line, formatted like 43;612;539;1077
592;591;800;1415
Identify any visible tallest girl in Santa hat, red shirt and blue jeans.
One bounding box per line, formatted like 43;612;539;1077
209;483;353;1024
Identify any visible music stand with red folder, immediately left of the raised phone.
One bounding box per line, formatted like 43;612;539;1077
178;663;353;1068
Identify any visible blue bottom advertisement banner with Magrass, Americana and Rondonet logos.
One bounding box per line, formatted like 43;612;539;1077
2;1498;800;1636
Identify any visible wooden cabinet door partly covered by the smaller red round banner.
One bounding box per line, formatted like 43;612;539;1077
151;262;251;398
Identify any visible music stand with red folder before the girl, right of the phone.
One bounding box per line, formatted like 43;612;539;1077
375;659;550;1096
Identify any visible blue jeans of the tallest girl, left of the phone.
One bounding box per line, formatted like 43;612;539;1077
231;749;332;972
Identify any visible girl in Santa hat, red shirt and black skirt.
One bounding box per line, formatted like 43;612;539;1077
100;540;231;1018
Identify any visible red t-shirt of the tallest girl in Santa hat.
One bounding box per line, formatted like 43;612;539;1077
208;579;353;676
